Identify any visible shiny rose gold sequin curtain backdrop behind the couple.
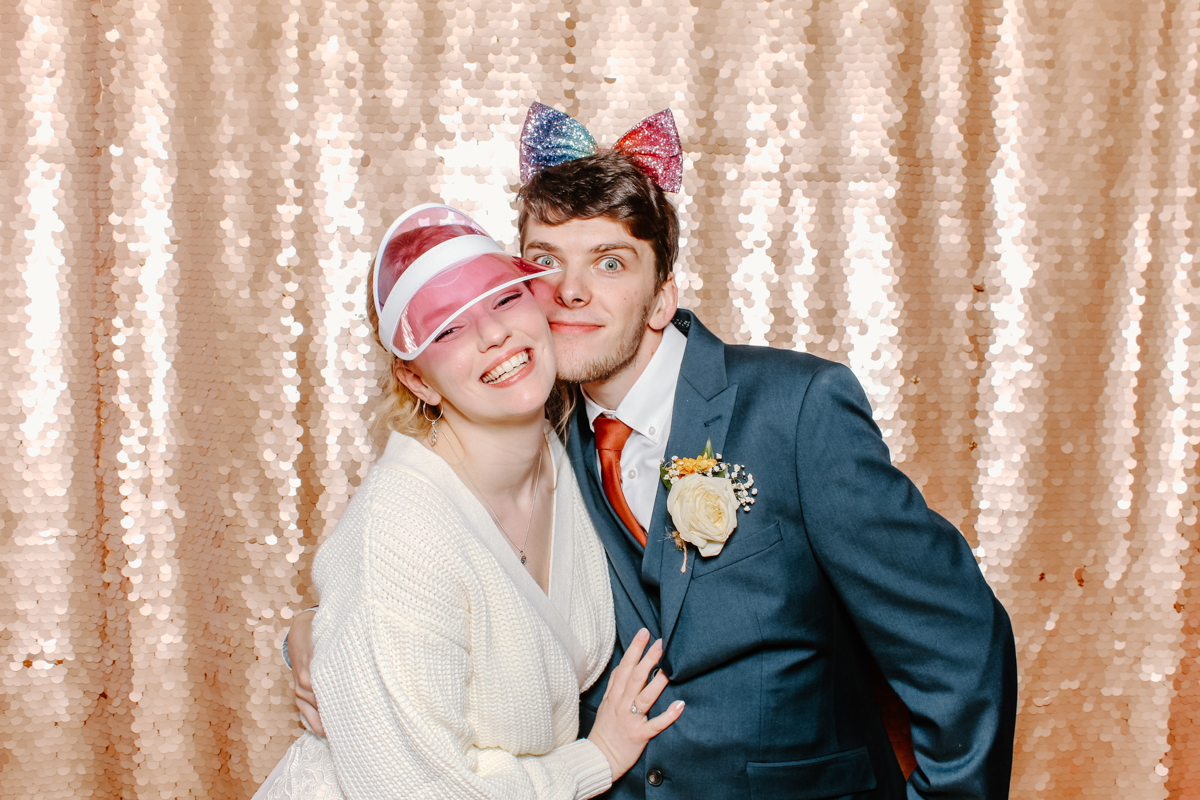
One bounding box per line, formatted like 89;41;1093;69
0;0;1200;799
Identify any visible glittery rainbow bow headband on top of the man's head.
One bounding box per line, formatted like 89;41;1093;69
521;103;683;192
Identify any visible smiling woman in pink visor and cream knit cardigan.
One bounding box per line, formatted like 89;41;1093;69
256;205;683;800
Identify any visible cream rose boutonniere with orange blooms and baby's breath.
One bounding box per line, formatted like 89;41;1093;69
659;439;758;572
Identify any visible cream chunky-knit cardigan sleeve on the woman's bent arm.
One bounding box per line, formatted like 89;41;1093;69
312;482;611;800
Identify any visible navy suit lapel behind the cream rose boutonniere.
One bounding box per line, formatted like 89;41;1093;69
646;312;738;646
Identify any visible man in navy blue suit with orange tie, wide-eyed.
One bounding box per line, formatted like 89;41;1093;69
518;143;1016;800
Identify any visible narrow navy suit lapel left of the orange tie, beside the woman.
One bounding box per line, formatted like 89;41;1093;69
568;403;659;638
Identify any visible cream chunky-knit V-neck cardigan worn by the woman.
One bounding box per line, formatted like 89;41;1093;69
258;433;614;800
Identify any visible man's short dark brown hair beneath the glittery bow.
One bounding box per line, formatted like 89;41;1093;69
517;150;679;288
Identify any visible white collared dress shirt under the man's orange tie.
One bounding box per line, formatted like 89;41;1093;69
583;325;688;531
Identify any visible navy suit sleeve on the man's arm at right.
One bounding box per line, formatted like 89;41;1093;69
797;365;1016;799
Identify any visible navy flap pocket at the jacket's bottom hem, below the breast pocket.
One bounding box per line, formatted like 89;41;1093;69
746;747;875;800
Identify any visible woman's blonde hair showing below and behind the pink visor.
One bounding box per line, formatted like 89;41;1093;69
367;252;577;452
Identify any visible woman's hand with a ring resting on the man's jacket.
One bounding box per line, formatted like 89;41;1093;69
588;628;683;781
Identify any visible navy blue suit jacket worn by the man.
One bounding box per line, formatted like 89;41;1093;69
569;312;1016;800
